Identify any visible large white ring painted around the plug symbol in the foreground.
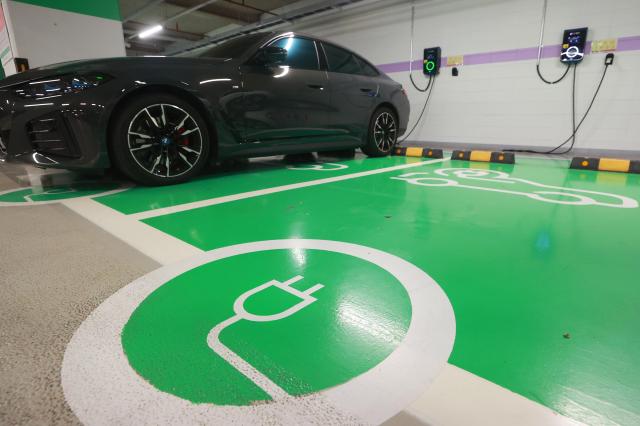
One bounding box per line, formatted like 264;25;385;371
61;239;455;424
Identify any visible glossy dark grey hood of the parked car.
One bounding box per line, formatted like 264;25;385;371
0;56;228;89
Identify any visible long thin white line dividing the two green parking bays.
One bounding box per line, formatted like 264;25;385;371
129;158;449;220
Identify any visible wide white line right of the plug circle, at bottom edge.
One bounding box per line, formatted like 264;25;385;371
385;364;582;426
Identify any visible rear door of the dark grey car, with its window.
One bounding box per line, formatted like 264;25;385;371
322;42;380;143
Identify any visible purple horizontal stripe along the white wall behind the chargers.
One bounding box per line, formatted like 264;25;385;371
378;36;640;73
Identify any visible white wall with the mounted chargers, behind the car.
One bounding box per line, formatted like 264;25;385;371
294;0;640;151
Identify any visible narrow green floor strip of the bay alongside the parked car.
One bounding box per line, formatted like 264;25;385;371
96;158;400;214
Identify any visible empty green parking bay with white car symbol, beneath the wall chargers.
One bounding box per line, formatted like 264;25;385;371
141;158;640;424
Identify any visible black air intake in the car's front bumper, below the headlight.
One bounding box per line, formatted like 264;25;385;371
27;113;80;158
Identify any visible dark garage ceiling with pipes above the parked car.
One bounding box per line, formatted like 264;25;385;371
119;0;424;56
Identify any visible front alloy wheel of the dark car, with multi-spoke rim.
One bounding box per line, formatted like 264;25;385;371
127;104;202;178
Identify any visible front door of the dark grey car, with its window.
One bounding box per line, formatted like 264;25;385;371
241;36;331;145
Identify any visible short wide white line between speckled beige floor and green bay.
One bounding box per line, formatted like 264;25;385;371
61;198;202;265
